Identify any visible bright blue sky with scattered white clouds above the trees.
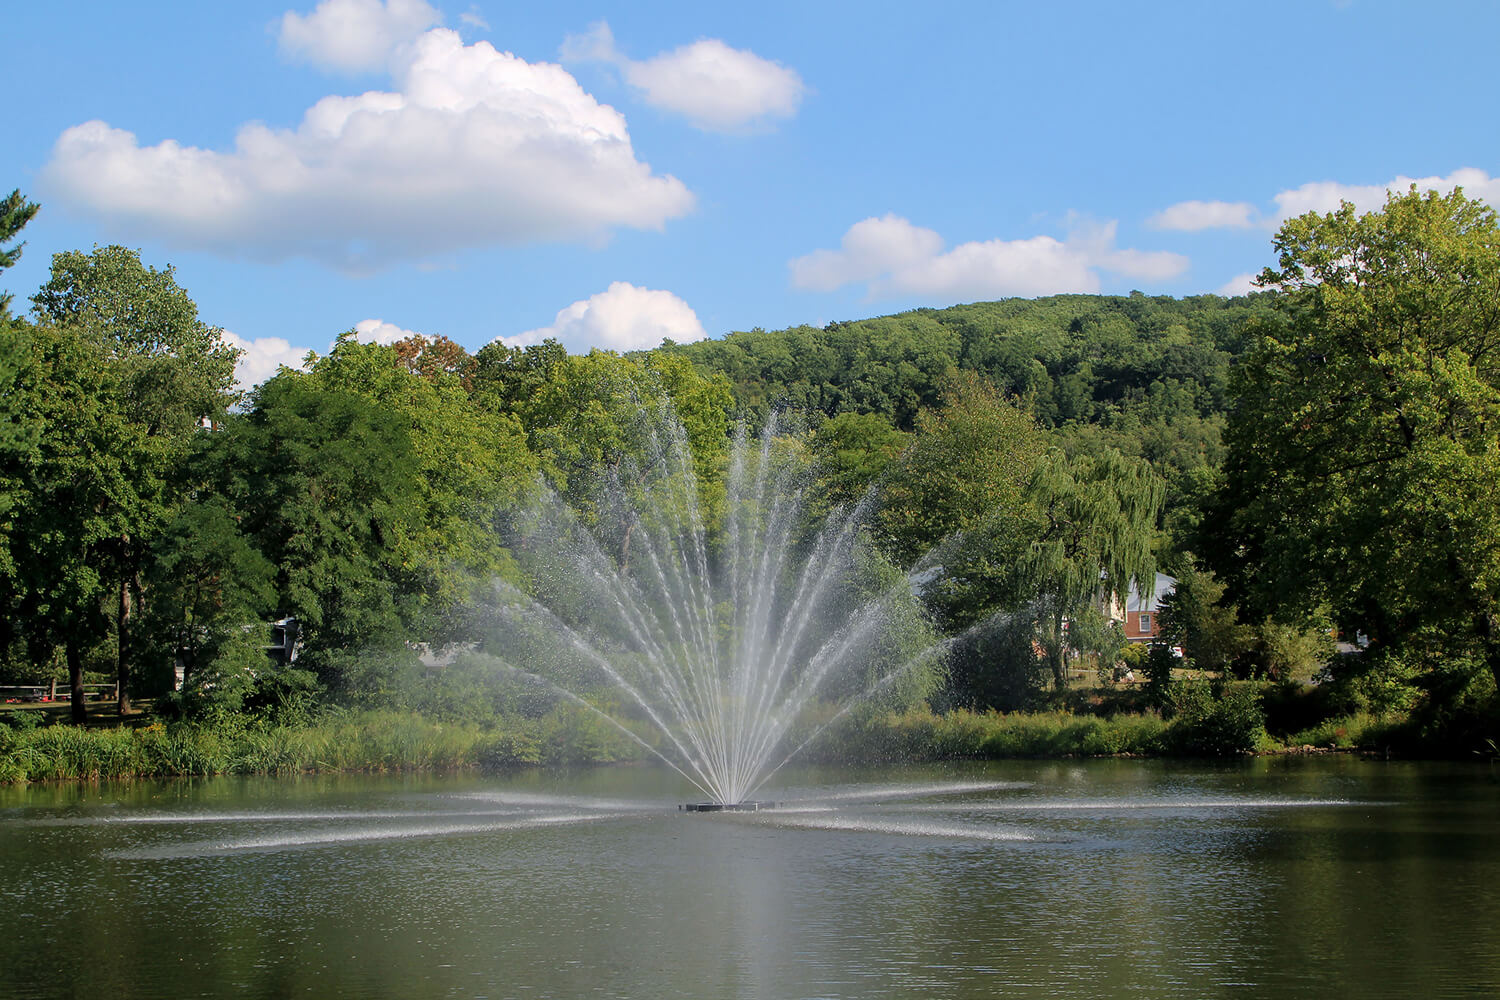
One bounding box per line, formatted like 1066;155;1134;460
0;0;1500;385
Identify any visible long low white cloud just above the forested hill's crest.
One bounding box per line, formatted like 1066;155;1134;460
791;214;1188;300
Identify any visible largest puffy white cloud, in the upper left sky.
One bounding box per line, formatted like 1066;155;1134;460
44;28;693;271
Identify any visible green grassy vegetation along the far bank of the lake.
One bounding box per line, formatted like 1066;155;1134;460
0;695;1421;784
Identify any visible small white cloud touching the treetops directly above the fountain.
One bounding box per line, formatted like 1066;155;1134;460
500;282;708;354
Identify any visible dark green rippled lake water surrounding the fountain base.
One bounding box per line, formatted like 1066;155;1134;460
0;757;1500;1000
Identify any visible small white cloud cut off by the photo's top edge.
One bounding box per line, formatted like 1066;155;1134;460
281;0;443;72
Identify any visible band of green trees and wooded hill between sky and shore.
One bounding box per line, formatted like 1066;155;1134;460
0;185;1500;749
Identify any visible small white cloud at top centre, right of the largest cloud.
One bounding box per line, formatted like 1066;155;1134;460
563;21;807;132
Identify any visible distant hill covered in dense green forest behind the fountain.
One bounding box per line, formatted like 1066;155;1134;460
668;292;1272;535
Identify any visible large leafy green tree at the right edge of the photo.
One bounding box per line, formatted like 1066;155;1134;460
1214;187;1500;707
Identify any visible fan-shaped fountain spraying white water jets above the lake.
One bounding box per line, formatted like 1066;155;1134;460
479;408;944;813
